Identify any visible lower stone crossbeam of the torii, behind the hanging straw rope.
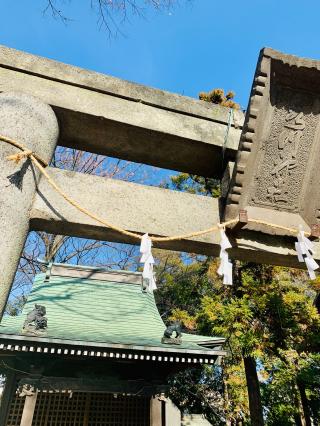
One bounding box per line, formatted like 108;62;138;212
30;168;320;268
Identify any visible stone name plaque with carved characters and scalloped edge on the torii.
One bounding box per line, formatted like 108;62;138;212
226;49;320;235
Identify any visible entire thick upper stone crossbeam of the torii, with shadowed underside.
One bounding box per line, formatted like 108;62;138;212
0;43;243;176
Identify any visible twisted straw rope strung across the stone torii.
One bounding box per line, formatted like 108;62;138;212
0;135;310;242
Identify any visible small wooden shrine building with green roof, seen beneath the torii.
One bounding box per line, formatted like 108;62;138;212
0;264;225;426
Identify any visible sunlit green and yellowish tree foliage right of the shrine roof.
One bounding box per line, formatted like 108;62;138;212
157;161;320;425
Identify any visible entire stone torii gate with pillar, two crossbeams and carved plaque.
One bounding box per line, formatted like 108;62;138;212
0;47;320;320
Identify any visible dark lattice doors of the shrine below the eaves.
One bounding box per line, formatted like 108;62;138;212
6;391;150;426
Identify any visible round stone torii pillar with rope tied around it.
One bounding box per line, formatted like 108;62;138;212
0;92;59;317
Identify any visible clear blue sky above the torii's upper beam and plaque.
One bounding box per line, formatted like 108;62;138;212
0;0;320;107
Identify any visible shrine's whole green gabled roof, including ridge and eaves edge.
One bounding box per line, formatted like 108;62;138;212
0;264;224;362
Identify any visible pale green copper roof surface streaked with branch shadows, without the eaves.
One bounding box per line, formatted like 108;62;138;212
0;266;225;351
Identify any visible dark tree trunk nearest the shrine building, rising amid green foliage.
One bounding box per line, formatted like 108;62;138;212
243;356;264;426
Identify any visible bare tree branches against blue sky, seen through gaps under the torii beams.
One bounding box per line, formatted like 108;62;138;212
8;147;158;312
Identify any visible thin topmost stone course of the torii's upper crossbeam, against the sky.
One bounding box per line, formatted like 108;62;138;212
0;45;243;125
